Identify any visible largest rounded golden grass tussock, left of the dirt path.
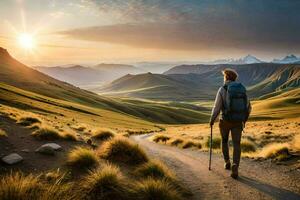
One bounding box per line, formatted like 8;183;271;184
98;137;148;164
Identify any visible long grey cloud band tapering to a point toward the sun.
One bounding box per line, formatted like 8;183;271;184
59;19;300;51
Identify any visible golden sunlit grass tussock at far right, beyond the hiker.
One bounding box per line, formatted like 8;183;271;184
259;143;290;160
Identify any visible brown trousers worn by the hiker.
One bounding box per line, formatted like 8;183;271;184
219;120;243;166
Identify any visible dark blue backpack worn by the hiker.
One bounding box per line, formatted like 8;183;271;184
222;82;248;122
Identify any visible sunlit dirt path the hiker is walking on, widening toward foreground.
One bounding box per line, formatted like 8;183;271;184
133;135;300;200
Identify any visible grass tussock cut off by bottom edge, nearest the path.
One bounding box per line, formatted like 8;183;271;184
135;179;182;200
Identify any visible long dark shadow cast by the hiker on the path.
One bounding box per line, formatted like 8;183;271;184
239;176;300;200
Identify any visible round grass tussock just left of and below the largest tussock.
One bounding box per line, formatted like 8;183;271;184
67;147;98;169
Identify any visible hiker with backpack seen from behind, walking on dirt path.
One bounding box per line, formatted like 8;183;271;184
210;68;251;179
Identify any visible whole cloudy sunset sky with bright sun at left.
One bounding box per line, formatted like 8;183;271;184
0;0;300;66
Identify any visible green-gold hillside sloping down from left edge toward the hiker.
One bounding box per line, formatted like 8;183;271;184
0;49;208;124
